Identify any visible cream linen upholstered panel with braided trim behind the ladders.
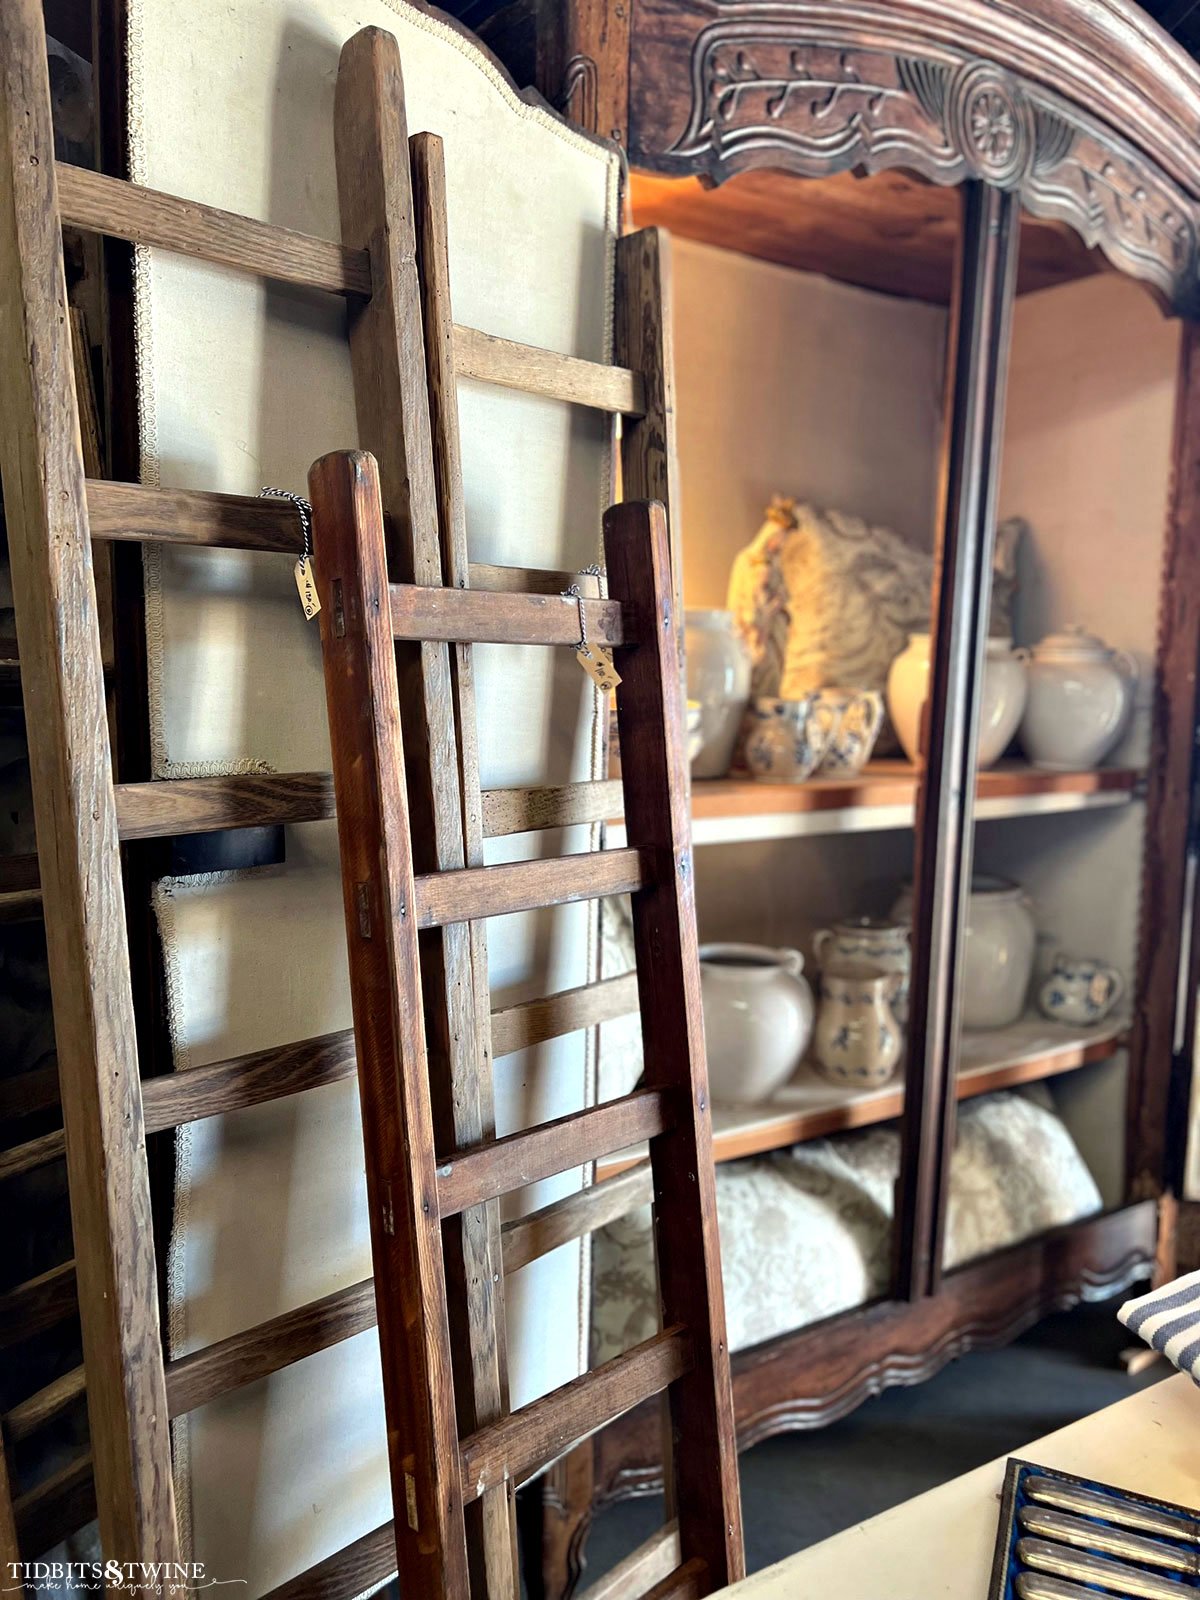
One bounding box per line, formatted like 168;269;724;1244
128;0;618;1597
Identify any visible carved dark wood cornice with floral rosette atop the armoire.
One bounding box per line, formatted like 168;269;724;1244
659;25;1200;312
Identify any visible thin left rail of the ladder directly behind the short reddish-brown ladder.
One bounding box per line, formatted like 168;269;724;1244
410;134;518;1594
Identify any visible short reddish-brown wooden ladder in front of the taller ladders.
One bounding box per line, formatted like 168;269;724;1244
309;435;742;1595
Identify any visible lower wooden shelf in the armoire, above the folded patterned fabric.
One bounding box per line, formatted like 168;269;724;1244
595;1011;1130;1179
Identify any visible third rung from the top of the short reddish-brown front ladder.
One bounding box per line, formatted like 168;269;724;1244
437;1090;667;1218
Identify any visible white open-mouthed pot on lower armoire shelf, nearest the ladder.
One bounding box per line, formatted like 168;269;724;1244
699;944;813;1106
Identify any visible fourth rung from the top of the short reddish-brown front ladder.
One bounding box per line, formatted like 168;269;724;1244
461;1326;693;1506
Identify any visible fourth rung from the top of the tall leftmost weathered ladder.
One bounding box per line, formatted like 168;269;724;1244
142;1027;355;1133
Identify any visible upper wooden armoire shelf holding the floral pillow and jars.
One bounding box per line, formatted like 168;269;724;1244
608;760;1141;848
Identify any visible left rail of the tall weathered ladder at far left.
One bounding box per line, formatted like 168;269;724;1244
0;0;176;1560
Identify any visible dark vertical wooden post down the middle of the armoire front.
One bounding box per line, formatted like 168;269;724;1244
894;182;1019;1299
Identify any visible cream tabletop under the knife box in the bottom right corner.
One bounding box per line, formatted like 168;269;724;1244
722;1374;1200;1600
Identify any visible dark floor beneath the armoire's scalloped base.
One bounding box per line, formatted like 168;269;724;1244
584;1304;1173;1584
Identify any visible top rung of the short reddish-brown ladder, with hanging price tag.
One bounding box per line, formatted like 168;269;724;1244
389;584;624;645
